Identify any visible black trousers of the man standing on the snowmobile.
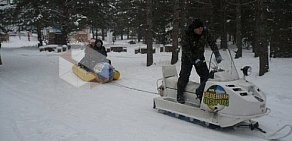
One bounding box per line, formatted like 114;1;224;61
177;55;209;100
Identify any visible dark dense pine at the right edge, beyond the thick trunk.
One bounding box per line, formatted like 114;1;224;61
267;0;292;57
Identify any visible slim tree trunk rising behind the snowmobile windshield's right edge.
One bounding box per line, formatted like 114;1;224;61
235;0;242;58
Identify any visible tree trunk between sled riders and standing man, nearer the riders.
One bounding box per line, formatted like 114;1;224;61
146;0;153;66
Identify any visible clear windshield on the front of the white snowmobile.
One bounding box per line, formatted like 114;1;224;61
205;49;239;82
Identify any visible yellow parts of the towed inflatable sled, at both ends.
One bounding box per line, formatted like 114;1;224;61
72;65;120;83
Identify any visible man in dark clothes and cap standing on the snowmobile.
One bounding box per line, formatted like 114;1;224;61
177;19;222;104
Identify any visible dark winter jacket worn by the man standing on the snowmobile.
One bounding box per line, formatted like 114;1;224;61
182;25;219;61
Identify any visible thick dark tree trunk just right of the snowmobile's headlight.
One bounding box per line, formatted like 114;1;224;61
257;0;269;76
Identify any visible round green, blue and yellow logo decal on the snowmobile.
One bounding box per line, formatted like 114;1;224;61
203;85;229;111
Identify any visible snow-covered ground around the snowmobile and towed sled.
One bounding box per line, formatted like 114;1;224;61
0;37;292;141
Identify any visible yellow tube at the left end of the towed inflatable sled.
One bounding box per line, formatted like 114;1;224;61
72;65;97;82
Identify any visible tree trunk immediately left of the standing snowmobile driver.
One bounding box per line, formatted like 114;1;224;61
171;0;180;65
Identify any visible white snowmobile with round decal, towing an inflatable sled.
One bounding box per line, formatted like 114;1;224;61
153;49;292;139
